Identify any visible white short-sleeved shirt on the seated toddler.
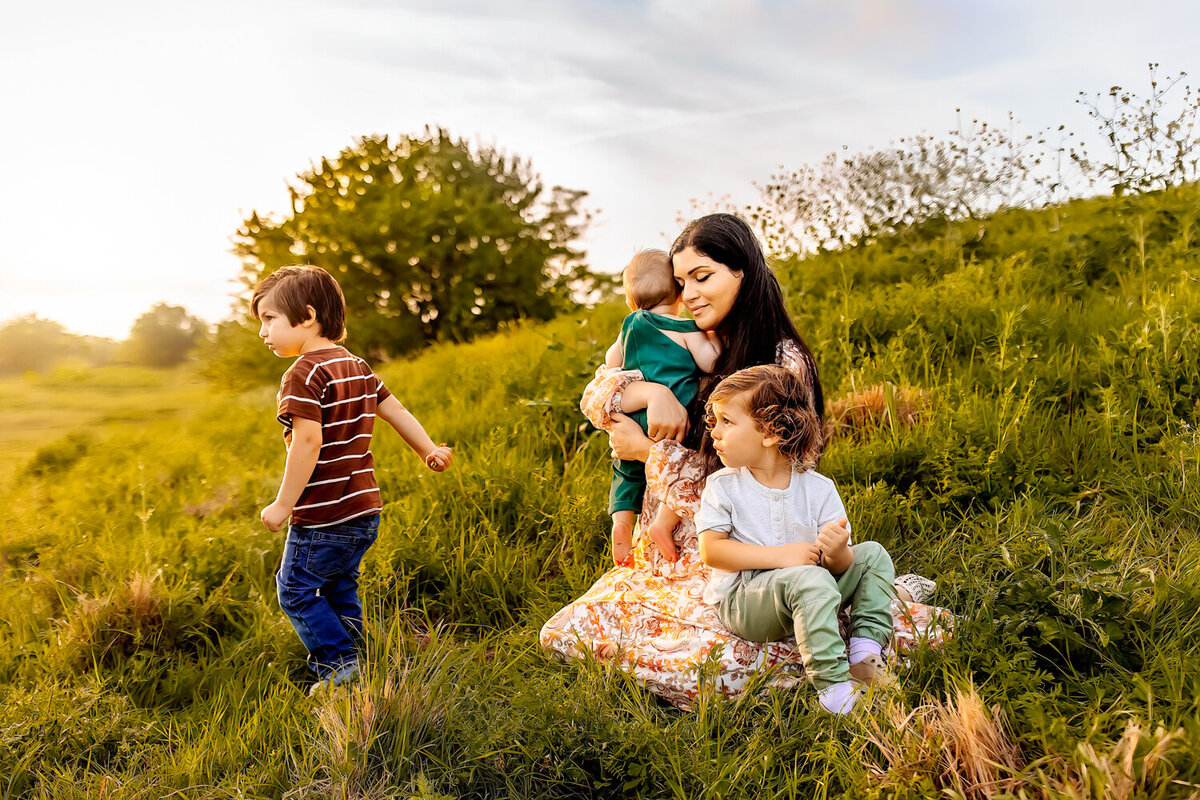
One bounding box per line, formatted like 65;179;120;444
696;467;850;604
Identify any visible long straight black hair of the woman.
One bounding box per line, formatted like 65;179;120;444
670;213;824;471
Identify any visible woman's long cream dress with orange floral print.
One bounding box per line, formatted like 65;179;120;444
540;341;952;708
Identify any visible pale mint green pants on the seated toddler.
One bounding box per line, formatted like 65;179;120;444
716;542;896;688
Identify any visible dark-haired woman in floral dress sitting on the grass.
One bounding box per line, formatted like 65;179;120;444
541;213;940;705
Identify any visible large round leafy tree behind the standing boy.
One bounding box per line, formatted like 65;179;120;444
234;128;595;356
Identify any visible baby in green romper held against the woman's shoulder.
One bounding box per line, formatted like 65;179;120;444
605;249;720;564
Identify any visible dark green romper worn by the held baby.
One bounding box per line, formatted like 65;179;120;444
608;309;702;515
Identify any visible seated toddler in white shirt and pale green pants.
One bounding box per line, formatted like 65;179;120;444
696;365;895;714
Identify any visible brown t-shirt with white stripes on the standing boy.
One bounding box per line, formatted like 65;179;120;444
278;347;391;528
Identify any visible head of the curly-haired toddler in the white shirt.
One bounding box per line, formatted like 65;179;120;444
704;363;822;470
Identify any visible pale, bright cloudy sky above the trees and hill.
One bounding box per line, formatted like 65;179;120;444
0;0;1200;338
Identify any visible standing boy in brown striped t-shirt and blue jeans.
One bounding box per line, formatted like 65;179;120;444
250;266;451;694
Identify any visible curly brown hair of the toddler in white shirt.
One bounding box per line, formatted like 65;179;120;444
704;363;824;471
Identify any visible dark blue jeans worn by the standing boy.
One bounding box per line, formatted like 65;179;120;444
275;513;379;679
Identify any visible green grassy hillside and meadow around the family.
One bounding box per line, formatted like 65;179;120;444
0;186;1200;798
